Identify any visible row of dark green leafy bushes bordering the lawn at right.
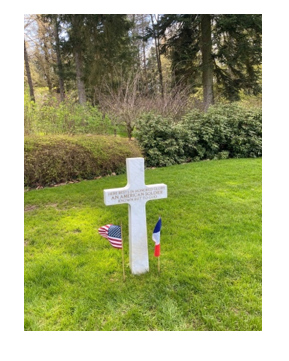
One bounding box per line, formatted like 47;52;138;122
136;104;262;166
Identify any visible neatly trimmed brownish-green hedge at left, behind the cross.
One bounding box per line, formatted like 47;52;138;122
24;135;141;188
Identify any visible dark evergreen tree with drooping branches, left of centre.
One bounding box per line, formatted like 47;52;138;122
61;14;134;104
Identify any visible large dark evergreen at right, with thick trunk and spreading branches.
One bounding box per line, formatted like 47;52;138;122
159;14;262;109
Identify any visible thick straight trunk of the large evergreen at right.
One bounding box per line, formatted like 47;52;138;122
201;14;214;112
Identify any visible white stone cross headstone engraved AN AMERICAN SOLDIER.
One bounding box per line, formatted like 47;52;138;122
103;158;167;274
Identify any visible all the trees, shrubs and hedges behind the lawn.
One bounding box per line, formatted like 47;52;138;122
24;14;262;187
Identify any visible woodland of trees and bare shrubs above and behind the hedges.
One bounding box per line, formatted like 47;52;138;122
24;14;262;138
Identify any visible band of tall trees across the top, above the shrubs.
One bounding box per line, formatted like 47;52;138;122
24;14;262;110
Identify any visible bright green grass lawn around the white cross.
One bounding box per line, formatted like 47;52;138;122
24;159;262;331
